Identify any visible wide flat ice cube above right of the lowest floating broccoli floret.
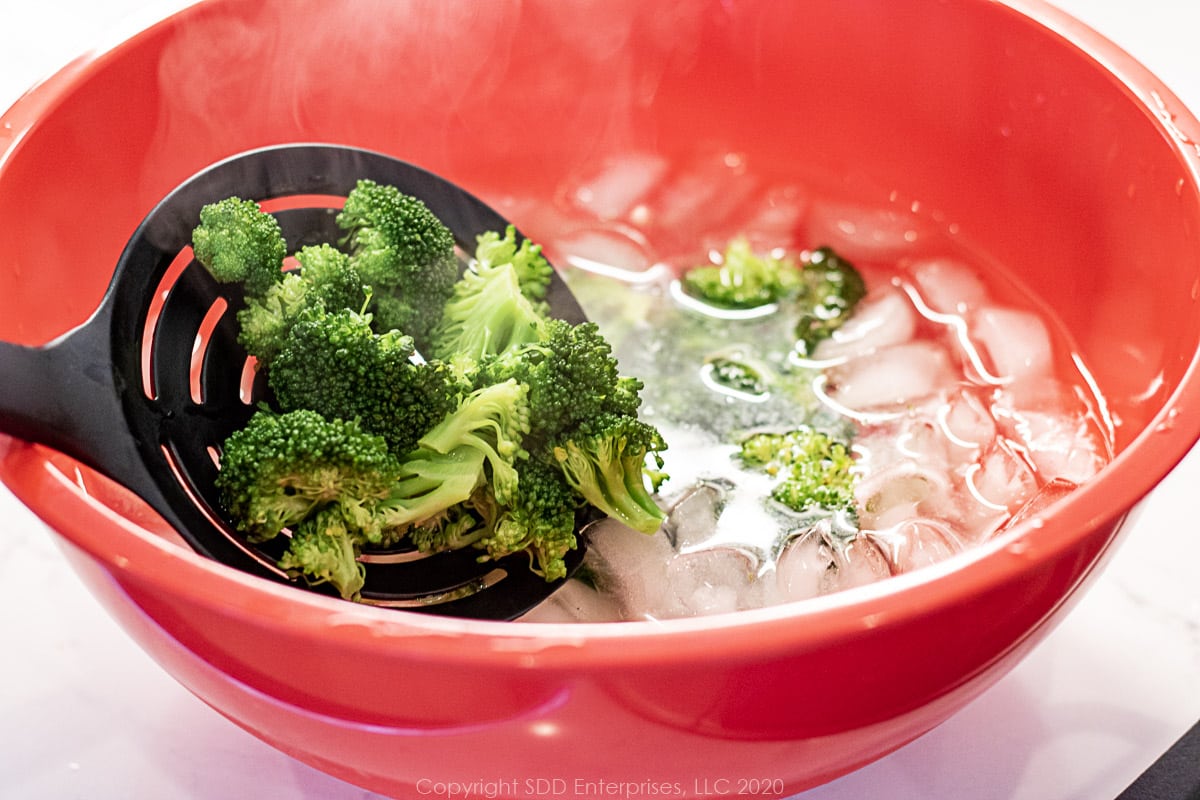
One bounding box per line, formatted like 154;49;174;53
826;342;954;411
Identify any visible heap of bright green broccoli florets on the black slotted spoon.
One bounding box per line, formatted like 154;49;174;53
196;181;666;599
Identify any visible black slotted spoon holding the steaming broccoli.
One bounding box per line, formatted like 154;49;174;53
0;144;590;619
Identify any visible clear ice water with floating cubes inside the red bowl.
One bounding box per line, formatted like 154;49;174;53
511;152;1111;621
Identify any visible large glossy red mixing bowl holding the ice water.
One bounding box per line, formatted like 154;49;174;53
0;0;1200;796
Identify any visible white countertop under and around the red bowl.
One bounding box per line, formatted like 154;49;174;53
0;0;1200;800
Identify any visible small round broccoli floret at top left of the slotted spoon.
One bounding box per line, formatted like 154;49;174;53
192;197;288;297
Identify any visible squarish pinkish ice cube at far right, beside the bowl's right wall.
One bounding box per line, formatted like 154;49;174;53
968;306;1054;383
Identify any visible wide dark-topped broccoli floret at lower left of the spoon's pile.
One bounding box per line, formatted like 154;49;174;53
216;410;401;541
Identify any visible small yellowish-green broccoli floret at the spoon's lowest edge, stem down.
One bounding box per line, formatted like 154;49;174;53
278;509;366;600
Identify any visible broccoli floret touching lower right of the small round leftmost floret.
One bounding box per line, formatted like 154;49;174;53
238;245;366;367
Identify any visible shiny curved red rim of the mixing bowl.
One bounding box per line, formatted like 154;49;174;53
0;0;1200;669
